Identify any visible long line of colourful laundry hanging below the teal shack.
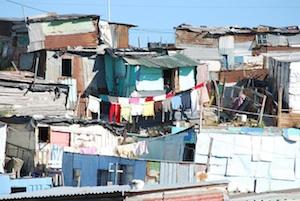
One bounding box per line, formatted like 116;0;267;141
89;82;209;123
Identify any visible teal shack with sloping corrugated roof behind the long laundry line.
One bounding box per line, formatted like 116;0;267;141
105;53;198;97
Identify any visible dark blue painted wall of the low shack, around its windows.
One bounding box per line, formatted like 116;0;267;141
63;152;146;186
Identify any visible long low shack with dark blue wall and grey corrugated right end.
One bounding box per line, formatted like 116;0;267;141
63;152;205;186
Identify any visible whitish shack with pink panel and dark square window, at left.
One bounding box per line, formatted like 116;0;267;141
1;116;123;177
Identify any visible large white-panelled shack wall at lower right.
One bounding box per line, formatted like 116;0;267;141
195;127;300;193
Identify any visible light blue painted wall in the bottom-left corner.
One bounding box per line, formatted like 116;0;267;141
0;175;52;195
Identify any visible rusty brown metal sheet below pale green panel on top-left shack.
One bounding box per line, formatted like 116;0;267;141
45;32;98;49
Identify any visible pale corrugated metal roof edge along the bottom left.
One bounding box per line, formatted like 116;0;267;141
0;185;131;200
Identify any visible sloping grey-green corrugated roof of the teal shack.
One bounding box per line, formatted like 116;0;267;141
123;54;198;68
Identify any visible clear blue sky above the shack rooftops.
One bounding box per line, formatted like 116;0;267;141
0;0;300;45
